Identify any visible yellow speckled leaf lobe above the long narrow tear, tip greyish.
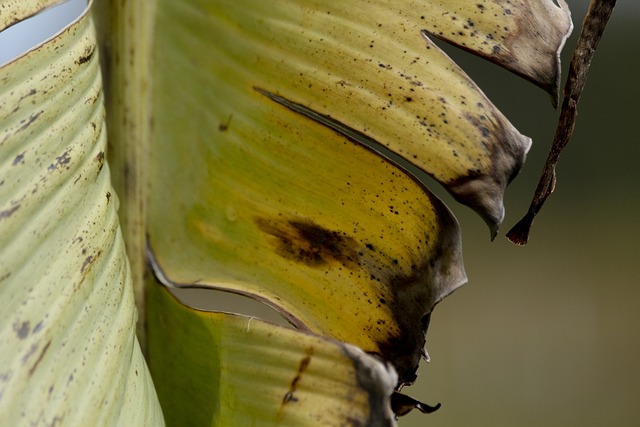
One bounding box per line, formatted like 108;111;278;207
149;0;530;233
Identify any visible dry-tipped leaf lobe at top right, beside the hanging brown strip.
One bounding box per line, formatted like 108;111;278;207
417;0;573;106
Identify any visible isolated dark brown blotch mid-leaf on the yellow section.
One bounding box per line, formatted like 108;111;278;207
255;218;358;269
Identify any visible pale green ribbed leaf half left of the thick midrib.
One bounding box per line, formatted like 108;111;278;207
0;5;163;426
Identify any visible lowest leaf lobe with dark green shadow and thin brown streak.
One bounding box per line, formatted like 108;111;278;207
147;283;397;427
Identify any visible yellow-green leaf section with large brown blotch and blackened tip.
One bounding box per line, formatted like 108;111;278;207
148;2;466;382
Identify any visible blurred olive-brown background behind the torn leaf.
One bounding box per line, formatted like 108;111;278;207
0;0;640;427
